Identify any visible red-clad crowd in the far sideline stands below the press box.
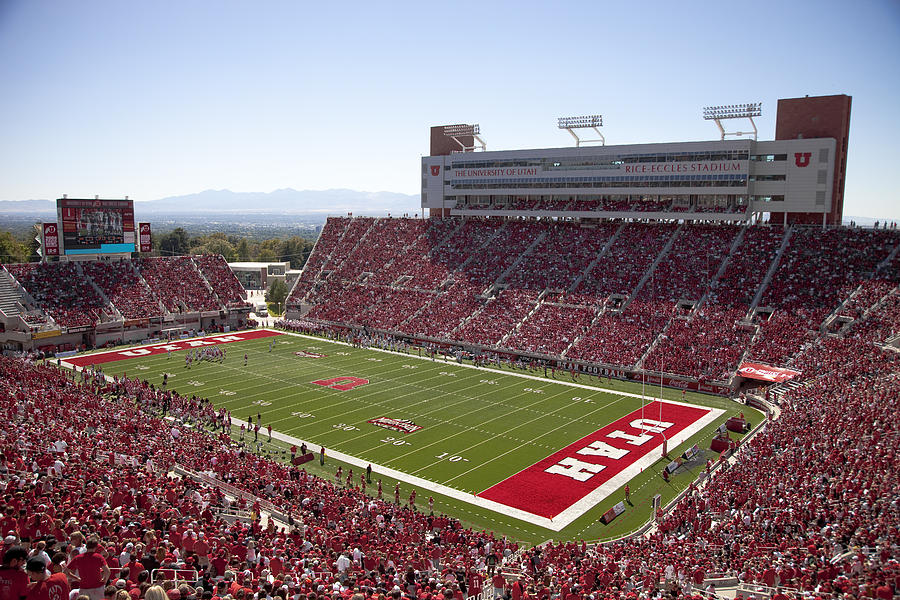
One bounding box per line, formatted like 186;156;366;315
280;218;900;379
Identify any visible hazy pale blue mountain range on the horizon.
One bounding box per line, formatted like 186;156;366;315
0;188;421;215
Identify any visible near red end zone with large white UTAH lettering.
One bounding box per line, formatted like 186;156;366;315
478;402;710;519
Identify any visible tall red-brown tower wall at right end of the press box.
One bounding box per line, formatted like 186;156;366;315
772;94;853;225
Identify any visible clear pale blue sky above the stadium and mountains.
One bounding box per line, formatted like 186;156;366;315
0;0;900;220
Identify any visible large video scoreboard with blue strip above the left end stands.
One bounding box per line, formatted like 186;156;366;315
56;198;135;255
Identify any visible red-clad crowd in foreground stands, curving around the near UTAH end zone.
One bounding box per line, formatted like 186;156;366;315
0;314;900;600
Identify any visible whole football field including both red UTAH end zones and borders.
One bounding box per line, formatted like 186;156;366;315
61;329;760;542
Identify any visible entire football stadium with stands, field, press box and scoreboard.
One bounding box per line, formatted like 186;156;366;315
0;95;900;600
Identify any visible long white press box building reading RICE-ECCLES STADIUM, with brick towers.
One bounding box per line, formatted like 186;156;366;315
422;95;851;226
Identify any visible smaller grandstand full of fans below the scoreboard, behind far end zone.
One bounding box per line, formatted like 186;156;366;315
0;256;250;352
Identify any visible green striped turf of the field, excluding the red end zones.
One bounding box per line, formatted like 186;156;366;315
88;335;761;543
